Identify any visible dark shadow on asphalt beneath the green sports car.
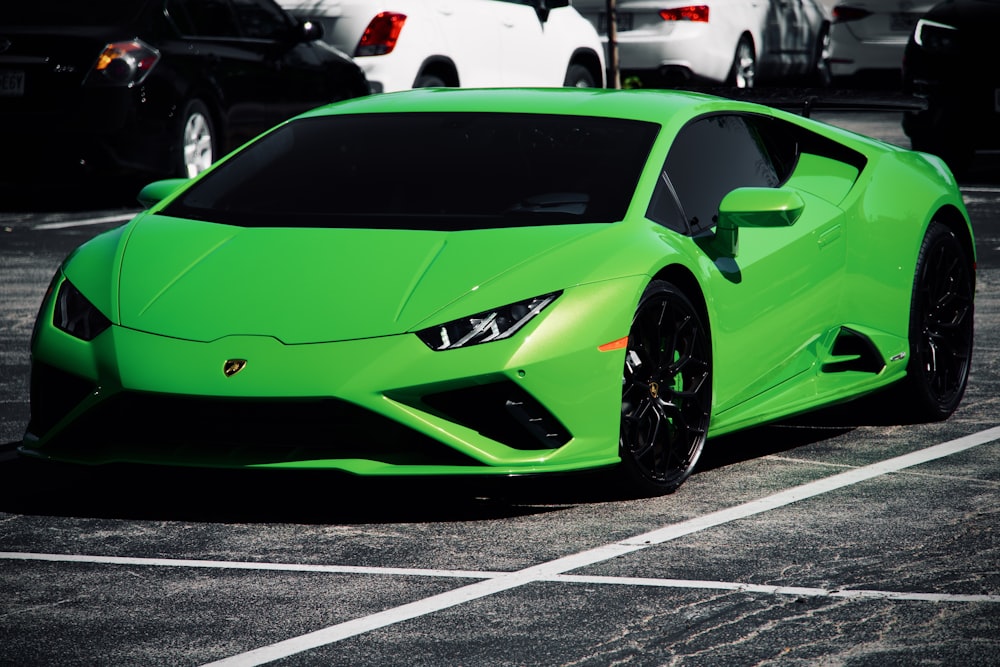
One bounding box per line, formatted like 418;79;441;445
0;386;920;525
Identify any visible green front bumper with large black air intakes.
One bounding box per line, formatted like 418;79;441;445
22;279;642;475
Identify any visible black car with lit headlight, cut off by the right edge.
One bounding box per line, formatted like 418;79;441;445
903;0;1000;171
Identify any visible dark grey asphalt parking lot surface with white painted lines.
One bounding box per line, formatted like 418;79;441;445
0;107;1000;667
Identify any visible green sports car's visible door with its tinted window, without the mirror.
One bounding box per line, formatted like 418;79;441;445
664;114;846;414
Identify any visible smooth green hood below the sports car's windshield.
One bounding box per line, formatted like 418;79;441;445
118;215;606;344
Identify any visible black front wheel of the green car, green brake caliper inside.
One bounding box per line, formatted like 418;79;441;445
619;281;712;495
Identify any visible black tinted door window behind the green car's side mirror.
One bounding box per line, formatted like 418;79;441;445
648;115;784;233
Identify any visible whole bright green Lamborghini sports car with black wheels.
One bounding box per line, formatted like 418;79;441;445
21;89;975;495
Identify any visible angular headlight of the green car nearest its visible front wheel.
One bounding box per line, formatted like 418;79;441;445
417;292;560;350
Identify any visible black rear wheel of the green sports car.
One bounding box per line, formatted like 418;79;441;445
903;222;975;421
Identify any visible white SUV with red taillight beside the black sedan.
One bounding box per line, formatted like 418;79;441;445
279;0;605;92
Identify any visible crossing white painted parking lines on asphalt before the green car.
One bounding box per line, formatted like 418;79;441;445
0;426;1000;667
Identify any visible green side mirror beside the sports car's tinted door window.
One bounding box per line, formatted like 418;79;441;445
712;188;806;257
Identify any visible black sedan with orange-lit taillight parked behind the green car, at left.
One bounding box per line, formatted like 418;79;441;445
0;0;368;183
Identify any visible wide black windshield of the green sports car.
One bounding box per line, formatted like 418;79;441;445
162;113;659;231
